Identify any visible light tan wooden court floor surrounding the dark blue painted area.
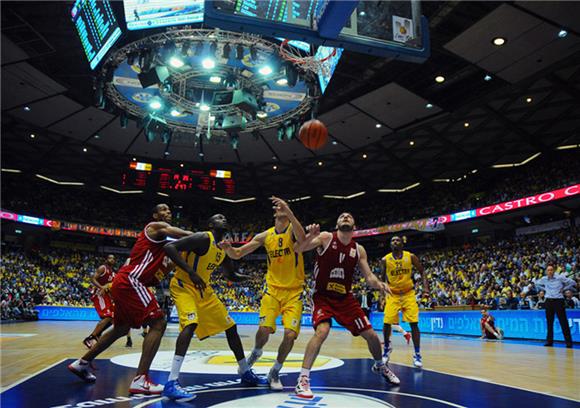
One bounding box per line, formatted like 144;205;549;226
0;321;580;400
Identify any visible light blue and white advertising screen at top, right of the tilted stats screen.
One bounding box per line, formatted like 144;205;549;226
123;0;204;30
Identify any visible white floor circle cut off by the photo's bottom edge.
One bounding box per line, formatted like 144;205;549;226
211;391;393;408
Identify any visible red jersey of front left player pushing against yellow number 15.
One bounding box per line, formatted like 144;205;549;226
117;224;171;287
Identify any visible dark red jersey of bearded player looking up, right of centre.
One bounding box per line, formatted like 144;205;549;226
314;232;359;298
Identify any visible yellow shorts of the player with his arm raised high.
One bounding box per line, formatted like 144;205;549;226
260;287;303;335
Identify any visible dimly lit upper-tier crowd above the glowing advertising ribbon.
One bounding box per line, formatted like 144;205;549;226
2;151;580;233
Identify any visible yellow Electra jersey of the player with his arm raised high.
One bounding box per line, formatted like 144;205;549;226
264;224;304;289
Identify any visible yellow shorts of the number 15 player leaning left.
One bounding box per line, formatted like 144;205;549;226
169;277;236;340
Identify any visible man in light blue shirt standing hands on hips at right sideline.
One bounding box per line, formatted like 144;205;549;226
536;265;576;348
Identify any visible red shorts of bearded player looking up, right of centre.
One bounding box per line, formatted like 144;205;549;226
312;294;372;336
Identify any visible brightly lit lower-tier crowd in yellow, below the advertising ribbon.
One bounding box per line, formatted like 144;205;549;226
0;225;580;320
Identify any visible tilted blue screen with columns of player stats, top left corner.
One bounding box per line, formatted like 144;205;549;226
71;0;121;69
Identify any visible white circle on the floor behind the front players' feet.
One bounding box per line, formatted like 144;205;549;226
111;350;344;374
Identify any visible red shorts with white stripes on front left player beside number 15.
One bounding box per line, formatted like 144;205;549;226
111;273;164;329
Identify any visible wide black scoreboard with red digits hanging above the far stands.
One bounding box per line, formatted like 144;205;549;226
121;162;236;195
